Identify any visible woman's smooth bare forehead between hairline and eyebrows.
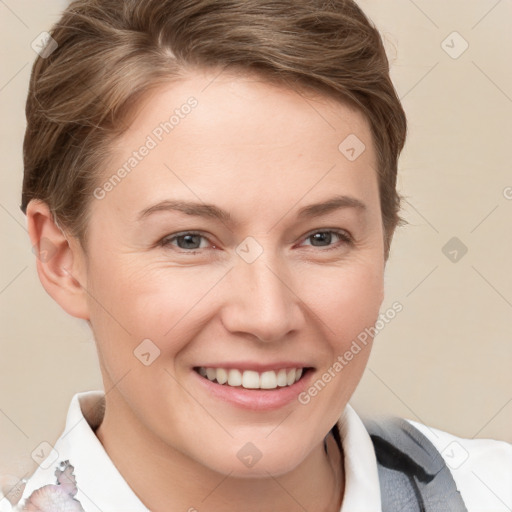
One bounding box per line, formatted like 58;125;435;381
94;71;378;226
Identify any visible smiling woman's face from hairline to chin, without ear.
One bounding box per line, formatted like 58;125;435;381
82;68;385;476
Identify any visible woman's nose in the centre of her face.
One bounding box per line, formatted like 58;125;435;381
222;252;304;342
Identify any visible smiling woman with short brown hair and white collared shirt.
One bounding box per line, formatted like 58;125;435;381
5;0;512;512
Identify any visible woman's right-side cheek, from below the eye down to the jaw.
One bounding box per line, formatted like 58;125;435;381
286;260;383;436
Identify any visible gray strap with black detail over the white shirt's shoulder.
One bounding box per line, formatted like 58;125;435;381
363;418;468;512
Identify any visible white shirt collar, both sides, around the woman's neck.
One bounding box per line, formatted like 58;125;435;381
21;391;382;512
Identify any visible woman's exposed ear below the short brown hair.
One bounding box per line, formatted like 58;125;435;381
27;200;89;320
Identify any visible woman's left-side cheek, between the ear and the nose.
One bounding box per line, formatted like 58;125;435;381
88;255;226;357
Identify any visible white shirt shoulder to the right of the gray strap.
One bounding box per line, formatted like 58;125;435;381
407;420;512;512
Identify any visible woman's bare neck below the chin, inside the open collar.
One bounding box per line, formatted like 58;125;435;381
96;392;344;512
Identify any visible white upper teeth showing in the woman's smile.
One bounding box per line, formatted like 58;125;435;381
199;367;302;389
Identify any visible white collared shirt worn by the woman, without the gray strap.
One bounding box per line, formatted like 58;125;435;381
0;391;512;512
